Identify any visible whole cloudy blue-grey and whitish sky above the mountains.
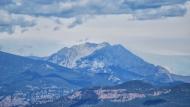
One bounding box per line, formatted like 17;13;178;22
0;0;190;75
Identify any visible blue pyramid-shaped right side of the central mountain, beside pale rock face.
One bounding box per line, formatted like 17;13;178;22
75;45;173;84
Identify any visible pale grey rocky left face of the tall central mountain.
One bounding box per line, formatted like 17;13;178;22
46;43;109;68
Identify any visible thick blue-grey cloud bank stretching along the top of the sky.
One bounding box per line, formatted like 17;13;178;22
0;0;189;32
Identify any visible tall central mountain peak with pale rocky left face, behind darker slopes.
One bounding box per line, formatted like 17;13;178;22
40;42;173;86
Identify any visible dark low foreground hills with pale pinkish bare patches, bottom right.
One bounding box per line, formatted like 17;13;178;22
34;81;190;107
